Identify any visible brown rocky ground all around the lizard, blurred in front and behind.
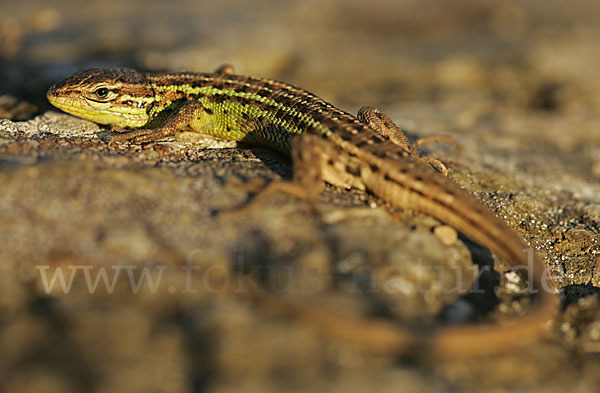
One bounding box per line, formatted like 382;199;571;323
0;0;600;393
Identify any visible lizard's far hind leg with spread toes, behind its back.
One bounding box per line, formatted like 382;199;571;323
357;106;460;176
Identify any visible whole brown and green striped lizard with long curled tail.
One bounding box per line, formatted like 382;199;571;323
47;66;558;357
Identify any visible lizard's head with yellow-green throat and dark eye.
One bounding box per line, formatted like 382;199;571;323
46;68;154;127
